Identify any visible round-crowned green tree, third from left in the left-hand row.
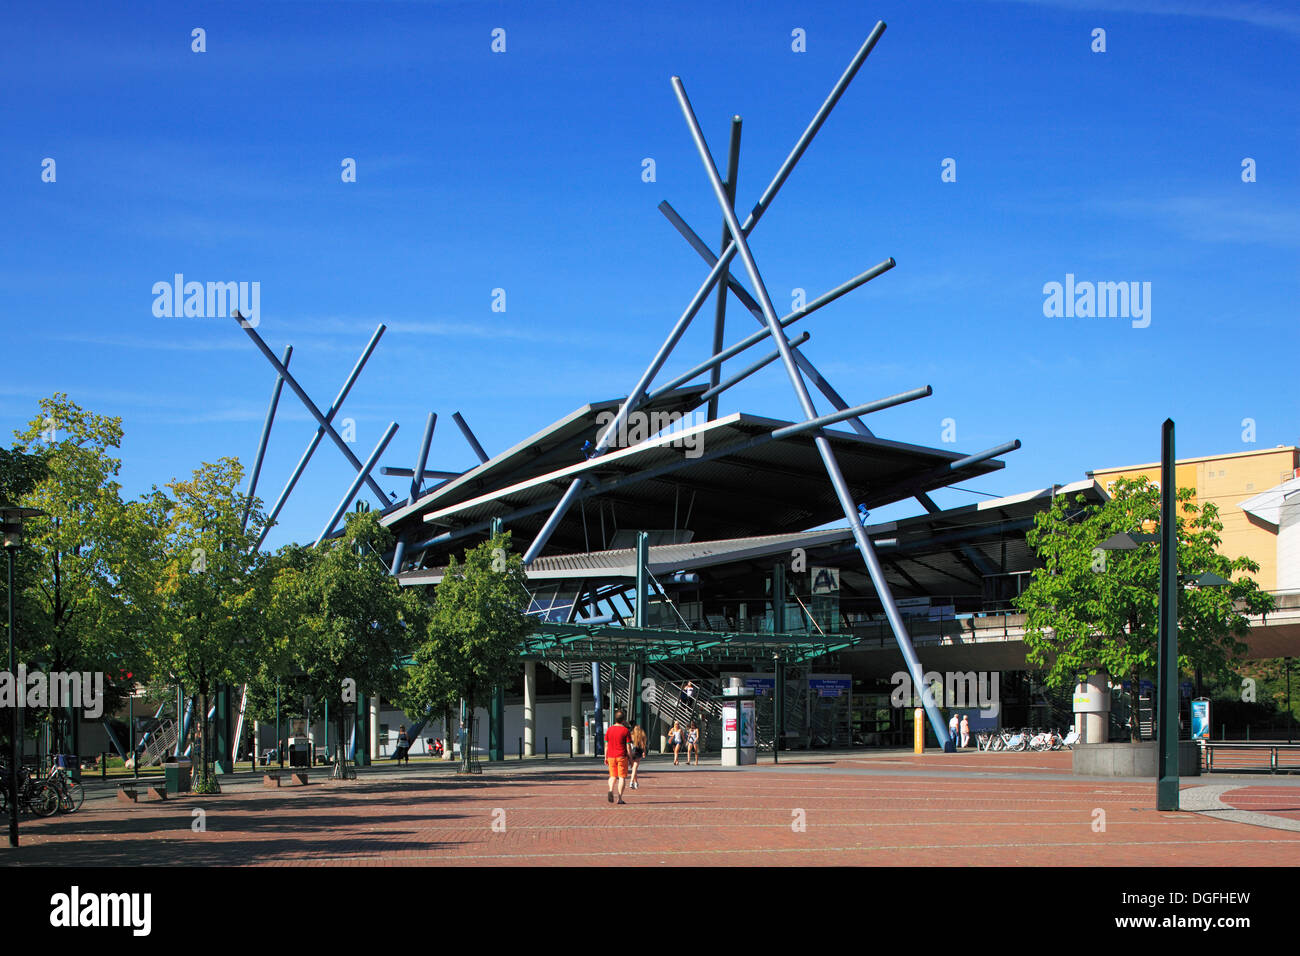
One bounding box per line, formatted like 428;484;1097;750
268;511;428;767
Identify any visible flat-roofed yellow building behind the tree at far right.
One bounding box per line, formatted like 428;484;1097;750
1087;445;1300;591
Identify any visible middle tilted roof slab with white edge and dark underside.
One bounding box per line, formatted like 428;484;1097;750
387;412;1004;564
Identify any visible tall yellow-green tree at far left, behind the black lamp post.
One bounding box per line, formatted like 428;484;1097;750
4;393;153;749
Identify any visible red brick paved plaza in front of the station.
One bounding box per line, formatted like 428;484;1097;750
4;753;1300;866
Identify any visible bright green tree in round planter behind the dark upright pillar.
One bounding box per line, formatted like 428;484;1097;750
1017;476;1273;741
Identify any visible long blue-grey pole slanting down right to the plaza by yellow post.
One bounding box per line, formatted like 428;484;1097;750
672;72;952;750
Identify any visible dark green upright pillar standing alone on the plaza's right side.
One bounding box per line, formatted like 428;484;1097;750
1156;419;1178;810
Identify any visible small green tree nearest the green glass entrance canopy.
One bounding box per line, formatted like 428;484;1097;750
404;532;532;767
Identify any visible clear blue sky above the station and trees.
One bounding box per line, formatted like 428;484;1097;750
0;0;1300;545
